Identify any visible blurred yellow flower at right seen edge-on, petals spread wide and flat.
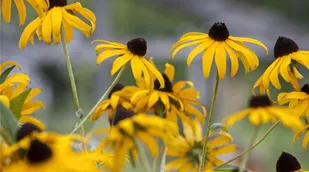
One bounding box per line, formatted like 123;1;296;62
223;95;303;129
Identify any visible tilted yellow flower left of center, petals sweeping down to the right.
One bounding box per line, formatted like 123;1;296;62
94;38;164;88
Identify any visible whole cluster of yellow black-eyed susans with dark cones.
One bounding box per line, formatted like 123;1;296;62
0;0;309;172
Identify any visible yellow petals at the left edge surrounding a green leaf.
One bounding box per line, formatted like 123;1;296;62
0;61;44;123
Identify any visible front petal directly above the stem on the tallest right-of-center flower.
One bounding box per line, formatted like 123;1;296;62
215;43;226;79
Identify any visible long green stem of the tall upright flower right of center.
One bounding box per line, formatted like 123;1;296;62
199;73;219;172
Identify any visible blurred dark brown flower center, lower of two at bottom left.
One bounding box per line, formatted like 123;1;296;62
26;140;53;164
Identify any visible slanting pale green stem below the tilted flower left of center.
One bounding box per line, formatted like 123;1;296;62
71;66;125;134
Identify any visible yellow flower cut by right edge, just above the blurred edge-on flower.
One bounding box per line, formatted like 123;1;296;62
277;84;309;116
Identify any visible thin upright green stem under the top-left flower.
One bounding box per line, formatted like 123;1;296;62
61;30;80;111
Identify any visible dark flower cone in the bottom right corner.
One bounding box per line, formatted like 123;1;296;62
276;152;308;172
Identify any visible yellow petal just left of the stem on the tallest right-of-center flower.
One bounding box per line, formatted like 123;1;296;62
202;42;218;78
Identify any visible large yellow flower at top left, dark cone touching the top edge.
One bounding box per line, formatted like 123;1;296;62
19;0;96;48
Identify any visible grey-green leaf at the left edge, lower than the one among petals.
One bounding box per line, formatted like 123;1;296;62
0;101;19;144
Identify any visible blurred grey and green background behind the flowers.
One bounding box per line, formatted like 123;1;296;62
0;0;309;172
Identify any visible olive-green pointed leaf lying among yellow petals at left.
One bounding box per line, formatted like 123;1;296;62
10;88;31;119
